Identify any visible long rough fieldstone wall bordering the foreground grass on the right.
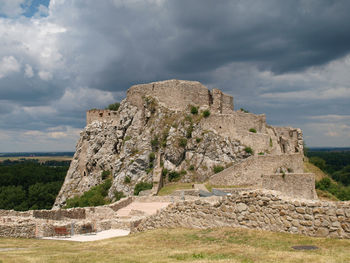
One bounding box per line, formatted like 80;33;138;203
133;190;350;238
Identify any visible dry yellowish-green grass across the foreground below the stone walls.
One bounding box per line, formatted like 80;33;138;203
0;228;350;263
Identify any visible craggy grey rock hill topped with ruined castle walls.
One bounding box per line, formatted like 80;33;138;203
54;80;303;208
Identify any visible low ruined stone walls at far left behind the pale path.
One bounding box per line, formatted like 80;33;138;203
0;197;134;238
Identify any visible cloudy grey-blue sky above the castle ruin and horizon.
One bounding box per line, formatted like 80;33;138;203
0;0;350;152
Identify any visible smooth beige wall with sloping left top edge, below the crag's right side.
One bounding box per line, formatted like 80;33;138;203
209;154;303;187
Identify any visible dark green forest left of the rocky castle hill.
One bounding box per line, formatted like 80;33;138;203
0;160;69;211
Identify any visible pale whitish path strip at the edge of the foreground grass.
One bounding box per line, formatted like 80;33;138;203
42;229;130;242
